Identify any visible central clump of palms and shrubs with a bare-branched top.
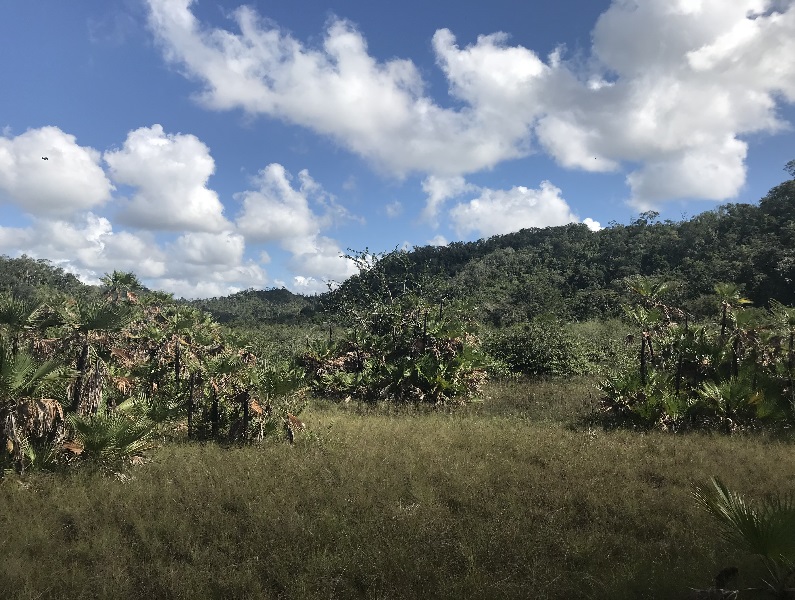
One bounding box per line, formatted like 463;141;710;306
301;252;486;404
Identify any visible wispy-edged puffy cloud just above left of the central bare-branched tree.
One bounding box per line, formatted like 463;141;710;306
236;163;355;285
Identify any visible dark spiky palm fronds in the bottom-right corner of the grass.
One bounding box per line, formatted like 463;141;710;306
693;478;795;598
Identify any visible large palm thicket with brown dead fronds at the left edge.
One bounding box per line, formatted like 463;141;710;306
0;272;303;472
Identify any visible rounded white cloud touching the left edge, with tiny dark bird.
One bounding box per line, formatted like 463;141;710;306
0;127;113;217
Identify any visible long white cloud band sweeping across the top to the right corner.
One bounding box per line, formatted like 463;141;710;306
148;0;795;209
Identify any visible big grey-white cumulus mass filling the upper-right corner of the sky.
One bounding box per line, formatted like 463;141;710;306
536;0;795;209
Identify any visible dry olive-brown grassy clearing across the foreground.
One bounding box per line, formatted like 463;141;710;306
0;381;795;599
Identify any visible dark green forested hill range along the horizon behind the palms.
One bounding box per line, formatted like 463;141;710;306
0;167;795;326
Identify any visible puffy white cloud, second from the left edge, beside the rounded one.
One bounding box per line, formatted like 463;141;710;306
104;125;232;232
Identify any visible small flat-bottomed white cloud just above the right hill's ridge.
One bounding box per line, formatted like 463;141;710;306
450;181;579;237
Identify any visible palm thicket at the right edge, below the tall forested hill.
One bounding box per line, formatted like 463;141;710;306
601;278;795;433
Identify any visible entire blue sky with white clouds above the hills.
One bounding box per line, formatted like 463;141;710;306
0;0;795;298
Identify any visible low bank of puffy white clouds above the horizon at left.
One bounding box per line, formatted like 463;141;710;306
0;125;352;297
